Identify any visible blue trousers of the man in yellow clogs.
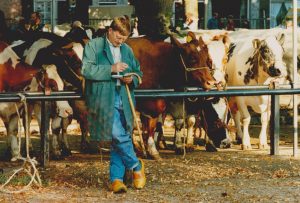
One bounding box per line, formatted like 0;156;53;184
110;108;139;182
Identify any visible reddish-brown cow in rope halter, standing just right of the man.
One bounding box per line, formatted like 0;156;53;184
127;32;221;159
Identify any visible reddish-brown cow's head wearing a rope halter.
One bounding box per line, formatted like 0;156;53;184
171;32;215;90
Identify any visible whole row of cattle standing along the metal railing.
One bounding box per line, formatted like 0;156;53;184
0;25;300;160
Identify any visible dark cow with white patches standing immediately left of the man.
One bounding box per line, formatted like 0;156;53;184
15;32;88;156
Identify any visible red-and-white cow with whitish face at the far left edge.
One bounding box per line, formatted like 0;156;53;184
0;42;66;160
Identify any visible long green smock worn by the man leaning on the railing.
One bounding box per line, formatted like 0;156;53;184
82;36;142;142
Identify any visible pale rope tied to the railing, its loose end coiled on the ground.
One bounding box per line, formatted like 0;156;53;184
0;93;42;194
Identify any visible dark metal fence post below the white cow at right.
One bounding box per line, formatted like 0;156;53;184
270;95;280;155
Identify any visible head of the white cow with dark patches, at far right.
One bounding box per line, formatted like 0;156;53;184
252;34;287;77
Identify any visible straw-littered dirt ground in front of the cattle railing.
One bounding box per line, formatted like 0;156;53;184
0;119;300;203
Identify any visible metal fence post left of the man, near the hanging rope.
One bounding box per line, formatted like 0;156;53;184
40;100;49;168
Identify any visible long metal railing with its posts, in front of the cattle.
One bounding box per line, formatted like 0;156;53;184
0;86;300;167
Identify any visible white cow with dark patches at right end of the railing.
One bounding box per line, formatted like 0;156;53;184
226;33;287;149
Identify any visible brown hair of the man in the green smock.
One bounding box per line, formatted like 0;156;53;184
109;15;131;36
